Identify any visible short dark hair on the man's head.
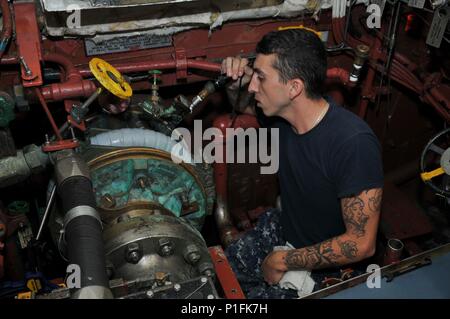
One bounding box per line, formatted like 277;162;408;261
256;29;327;99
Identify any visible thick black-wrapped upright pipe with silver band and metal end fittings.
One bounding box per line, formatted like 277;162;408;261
55;150;113;299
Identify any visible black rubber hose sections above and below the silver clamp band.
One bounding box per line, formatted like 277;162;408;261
59;176;109;287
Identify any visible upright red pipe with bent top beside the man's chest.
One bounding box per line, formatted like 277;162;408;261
213;114;259;246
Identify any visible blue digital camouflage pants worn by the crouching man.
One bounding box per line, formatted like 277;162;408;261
225;209;298;299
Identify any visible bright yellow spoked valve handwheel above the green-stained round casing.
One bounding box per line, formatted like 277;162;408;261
89;58;133;100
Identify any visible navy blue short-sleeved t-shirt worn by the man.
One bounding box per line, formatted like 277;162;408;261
256;101;383;248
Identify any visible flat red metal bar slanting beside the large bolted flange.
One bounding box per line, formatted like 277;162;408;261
208;246;245;299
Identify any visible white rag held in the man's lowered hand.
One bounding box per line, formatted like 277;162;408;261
273;243;315;298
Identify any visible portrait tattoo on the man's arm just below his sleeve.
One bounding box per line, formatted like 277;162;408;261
342;196;369;238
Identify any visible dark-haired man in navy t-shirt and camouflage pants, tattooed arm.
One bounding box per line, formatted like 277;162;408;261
222;29;383;298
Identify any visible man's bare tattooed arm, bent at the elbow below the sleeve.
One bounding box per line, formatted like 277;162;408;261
284;188;382;270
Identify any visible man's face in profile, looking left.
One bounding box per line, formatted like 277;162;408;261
248;54;291;116
